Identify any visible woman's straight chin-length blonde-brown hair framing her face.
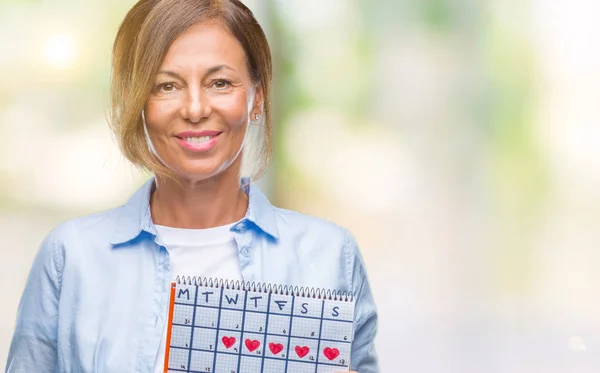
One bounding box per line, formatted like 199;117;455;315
110;0;273;180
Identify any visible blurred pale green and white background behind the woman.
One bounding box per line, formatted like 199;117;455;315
0;0;600;373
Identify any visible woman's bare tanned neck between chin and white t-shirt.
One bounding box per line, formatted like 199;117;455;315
150;172;248;229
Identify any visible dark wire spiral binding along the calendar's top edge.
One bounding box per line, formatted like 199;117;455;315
175;276;354;302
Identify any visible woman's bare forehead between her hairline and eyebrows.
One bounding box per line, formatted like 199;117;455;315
162;22;247;74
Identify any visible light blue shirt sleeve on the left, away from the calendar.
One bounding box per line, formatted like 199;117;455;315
6;230;62;373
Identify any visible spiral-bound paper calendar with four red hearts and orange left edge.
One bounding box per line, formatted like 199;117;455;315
164;277;354;373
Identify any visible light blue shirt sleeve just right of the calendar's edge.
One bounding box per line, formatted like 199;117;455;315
346;233;379;373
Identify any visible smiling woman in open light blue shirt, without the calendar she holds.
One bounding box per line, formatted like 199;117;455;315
7;0;378;373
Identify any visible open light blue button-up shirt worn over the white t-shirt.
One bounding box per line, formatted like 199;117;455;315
7;180;379;373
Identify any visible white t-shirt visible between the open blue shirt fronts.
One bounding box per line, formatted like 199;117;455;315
154;224;242;373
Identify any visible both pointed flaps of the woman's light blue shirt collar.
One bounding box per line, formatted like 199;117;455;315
111;178;279;245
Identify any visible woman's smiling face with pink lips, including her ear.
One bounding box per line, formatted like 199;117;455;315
145;23;262;182
